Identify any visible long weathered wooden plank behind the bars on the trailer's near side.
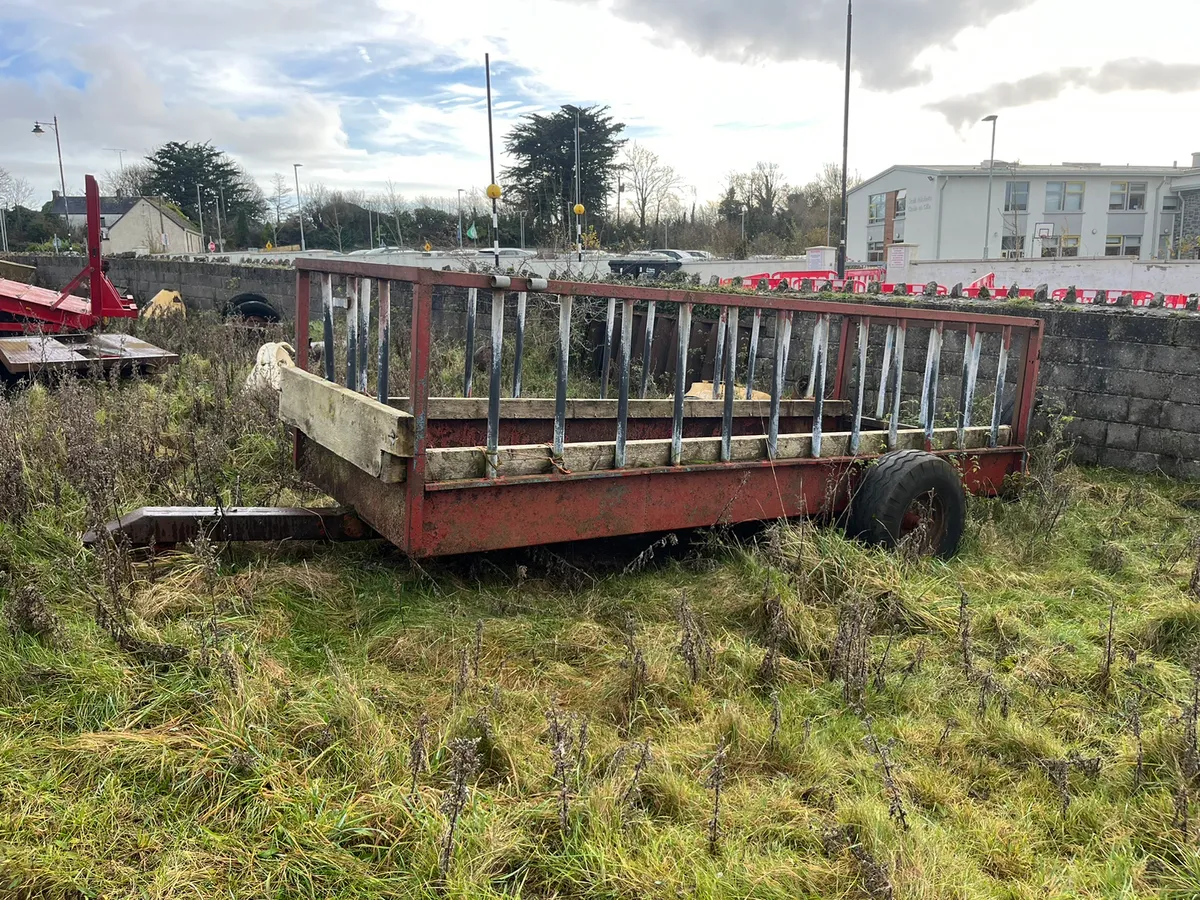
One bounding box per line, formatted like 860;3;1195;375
426;426;1010;481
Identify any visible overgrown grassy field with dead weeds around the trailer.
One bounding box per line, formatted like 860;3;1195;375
0;329;1200;900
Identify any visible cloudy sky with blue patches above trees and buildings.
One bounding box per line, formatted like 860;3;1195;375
0;0;1200;206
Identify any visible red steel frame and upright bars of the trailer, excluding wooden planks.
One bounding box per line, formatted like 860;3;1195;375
295;258;1043;557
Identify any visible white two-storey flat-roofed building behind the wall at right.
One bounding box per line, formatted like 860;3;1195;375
846;154;1200;263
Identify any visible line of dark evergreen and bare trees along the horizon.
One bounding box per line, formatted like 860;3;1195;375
0;106;859;257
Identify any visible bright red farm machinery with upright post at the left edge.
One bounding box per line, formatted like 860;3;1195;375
0;175;175;376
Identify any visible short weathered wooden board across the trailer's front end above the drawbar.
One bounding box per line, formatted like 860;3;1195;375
280;366;414;482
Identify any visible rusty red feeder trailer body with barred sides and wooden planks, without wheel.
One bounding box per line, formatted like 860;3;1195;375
280;259;1042;558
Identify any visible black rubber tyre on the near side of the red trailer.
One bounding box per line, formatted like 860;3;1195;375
847;450;967;558
